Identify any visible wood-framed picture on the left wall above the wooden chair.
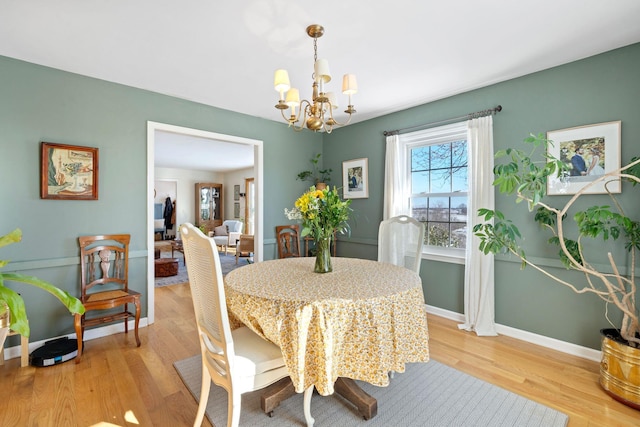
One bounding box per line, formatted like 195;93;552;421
40;142;98;200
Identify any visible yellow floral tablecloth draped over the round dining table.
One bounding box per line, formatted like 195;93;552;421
225;258;429;395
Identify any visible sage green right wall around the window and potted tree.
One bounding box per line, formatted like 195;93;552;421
324;44;640;348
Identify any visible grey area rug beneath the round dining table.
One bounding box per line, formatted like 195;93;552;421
174;355;569;427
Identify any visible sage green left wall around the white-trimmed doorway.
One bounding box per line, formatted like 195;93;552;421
0;57;322;345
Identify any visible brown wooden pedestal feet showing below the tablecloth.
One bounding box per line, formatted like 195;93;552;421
260;377;378;420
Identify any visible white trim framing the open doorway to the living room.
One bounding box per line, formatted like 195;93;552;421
147;121;264;324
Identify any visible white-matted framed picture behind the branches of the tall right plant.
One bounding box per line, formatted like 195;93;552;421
547;121;621;196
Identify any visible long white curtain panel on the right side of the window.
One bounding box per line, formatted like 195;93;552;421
458;116;498;336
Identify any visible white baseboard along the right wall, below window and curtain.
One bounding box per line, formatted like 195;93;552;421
426;305;602;362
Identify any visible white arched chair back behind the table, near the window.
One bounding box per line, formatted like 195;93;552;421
378;215;424;274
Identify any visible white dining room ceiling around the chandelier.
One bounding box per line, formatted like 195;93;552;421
0;0;640;172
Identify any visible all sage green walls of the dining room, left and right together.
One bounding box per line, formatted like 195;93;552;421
0;44;640;348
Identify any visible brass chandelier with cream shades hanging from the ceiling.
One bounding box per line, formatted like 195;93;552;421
274;24;358;133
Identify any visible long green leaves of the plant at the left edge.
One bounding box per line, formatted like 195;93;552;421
0;228;84;340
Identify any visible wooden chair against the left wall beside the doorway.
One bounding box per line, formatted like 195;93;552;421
74;234;141;363
